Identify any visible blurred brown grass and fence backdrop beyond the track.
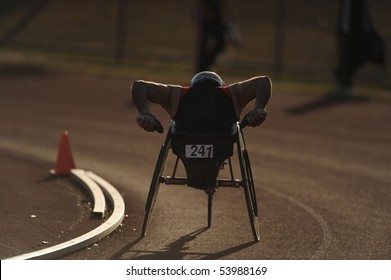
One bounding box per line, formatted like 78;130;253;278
0;0;391;90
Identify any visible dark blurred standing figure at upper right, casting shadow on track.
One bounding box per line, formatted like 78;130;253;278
334;0;386;97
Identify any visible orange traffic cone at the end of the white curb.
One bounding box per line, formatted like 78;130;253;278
50;131;75;175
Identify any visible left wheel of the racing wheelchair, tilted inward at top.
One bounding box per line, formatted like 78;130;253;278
141;132;171;236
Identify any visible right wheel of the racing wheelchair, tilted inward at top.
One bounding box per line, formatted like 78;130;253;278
238;129;260;241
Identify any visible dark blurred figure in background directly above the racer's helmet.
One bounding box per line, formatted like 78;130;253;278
196;0;241;72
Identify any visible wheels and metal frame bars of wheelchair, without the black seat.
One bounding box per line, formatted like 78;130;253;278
142;122;260;241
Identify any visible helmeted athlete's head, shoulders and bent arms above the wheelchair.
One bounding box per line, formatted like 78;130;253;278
131;71;272;133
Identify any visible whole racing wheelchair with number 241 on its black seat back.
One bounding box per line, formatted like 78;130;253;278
142;114;260;241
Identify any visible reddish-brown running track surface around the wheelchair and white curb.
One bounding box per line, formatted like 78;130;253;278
0;73;391;259
